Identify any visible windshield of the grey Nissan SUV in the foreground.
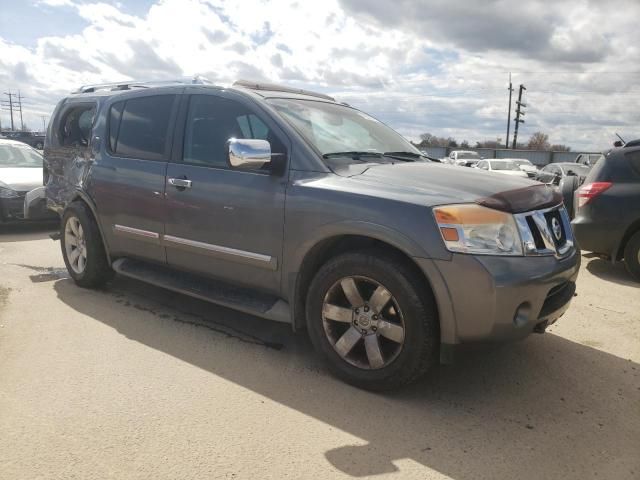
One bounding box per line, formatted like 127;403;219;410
269;98;421;155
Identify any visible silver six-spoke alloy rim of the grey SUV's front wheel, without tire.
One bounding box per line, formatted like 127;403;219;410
322;276;405;370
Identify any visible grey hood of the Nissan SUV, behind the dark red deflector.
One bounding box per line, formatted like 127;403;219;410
335;162;537;205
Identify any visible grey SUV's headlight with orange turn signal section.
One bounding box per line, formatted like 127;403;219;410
433;204;523;255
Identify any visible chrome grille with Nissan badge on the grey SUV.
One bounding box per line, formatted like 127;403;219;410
515;206;573;257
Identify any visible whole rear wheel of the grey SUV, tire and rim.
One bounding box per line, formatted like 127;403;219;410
60;202;113;288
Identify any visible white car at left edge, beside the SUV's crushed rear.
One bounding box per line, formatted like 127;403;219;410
0;139;56;224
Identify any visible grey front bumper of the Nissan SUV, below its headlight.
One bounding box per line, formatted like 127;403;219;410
416;249;580;344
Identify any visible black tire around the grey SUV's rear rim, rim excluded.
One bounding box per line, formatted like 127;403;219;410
60;201;113;288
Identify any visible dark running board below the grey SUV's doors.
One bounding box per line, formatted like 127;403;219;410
111;258;291;323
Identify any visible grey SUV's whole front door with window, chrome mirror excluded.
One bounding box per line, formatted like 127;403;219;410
164;90;286;293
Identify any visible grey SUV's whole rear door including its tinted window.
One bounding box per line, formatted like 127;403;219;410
87;94;178;263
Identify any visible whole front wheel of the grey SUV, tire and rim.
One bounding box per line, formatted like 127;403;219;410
306;251;439;390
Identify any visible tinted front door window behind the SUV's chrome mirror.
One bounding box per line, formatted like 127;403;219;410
183;95;285;167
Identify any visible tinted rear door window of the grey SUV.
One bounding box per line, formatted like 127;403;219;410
109;95;175;160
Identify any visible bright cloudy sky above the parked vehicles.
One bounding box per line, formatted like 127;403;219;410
0;0;640;151
